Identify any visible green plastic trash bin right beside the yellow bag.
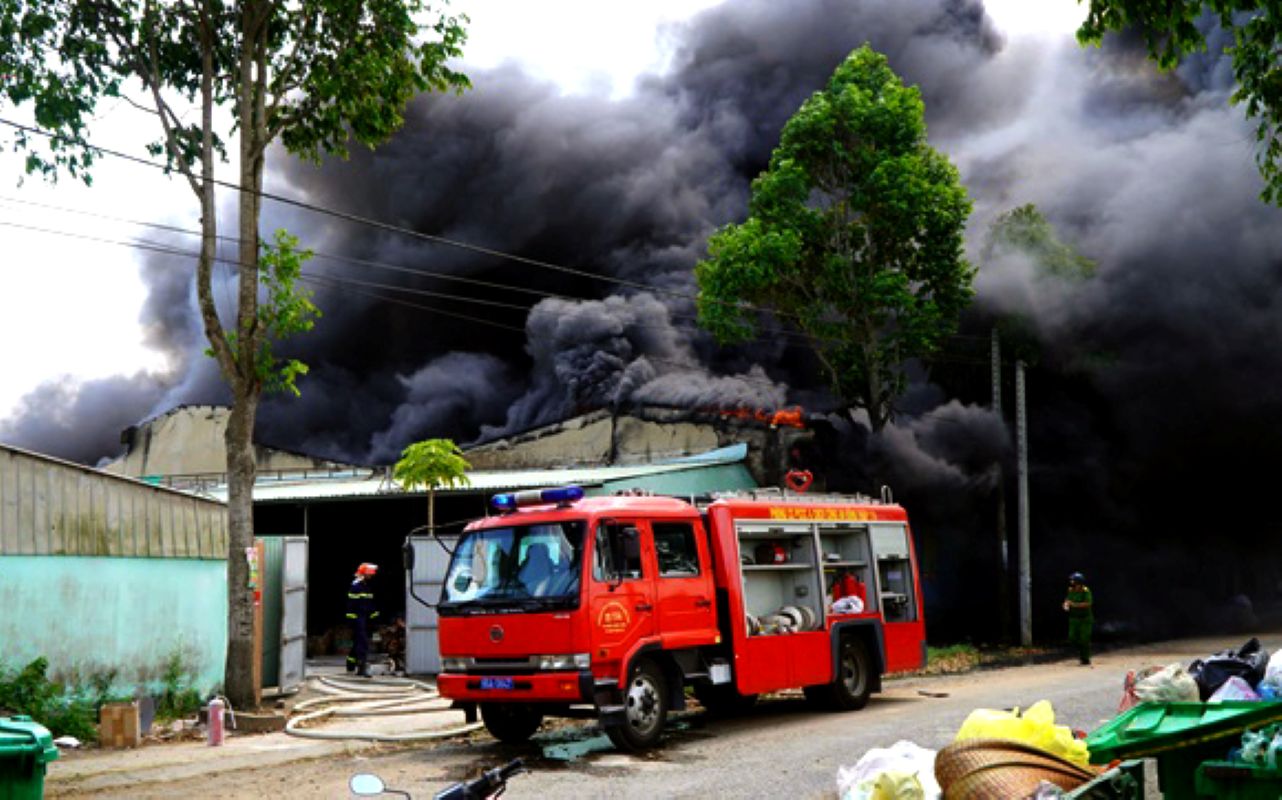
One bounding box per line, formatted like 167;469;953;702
1086;700;1282;800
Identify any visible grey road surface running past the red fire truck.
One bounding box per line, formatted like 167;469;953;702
74;631;1282;800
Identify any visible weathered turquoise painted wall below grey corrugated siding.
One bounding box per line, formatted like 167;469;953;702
0;555;227;695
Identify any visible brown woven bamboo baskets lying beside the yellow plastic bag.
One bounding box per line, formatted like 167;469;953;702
935;738;1096;800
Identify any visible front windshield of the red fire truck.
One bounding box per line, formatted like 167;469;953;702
441;519;585;613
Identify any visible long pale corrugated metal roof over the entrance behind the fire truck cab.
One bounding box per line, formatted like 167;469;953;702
209;447;744;503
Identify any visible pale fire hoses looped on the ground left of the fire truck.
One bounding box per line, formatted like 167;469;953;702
285;677;482;742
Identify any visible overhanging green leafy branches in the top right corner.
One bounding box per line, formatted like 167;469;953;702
1077;0;1282;205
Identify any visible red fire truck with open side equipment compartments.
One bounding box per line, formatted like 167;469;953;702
437;487;926;750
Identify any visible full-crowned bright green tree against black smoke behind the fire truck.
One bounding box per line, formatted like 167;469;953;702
695;46;974;429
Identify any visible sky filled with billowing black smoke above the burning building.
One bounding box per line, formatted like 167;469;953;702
0;0;1282;638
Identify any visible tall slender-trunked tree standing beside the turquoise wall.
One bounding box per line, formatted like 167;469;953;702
0;0;467;708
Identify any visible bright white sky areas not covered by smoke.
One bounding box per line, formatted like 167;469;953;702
0;0;1085;419
